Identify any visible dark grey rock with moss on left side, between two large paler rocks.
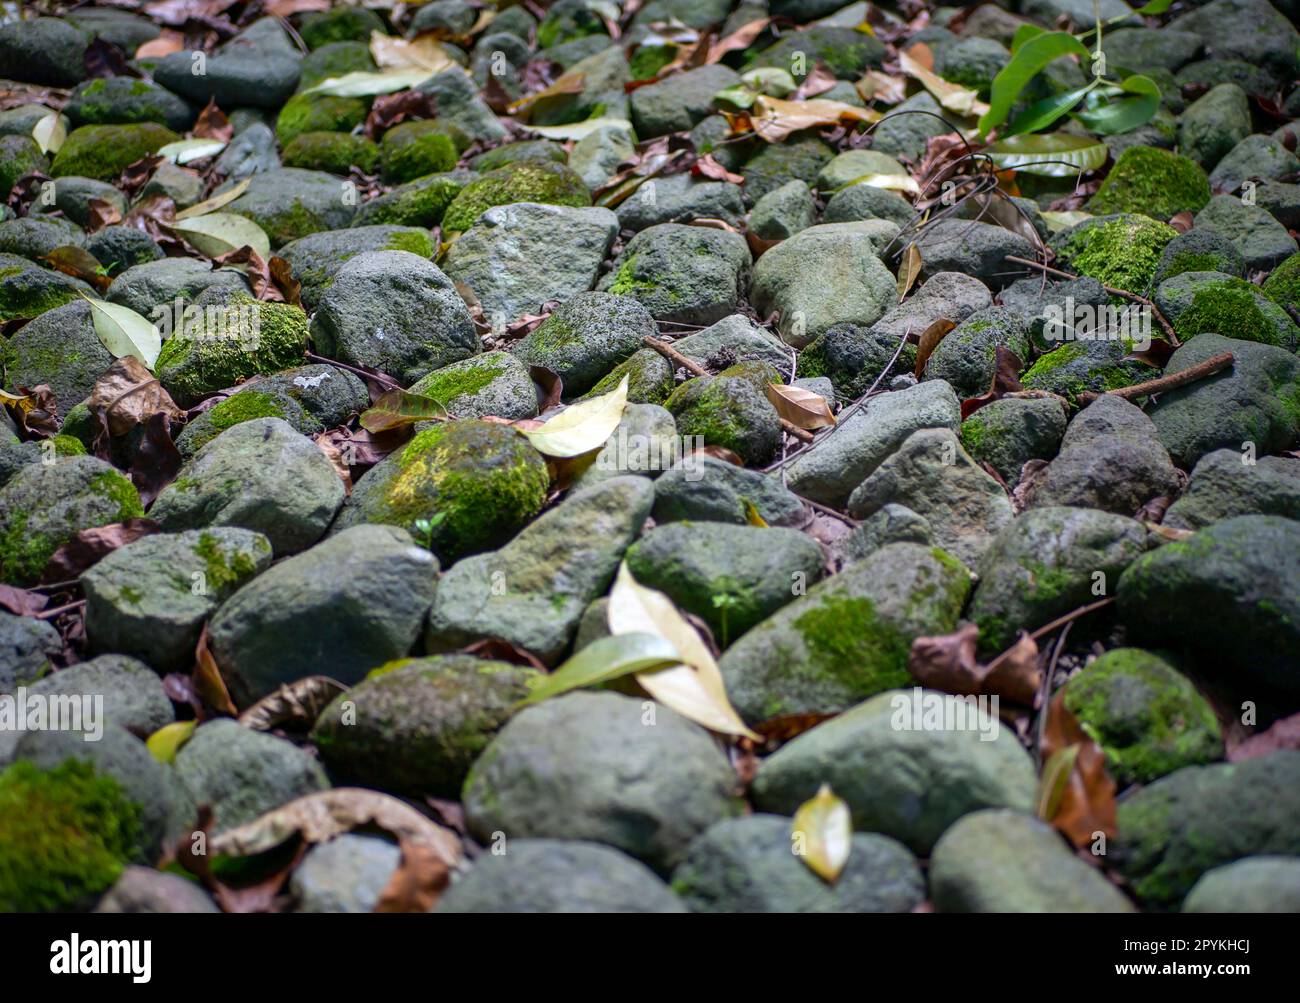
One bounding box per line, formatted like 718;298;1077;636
597;223;750;325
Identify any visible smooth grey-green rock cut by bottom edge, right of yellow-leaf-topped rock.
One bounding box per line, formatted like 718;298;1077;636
930;808;1135;912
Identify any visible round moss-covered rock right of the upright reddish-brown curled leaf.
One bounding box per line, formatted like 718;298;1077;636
1063;648;1223;787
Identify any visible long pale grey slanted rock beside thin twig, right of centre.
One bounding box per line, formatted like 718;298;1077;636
785;381;961;507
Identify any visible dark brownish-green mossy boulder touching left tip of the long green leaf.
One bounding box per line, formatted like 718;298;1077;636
312;655;540;798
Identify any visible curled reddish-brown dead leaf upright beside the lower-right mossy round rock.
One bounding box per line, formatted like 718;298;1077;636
1040;690;1115;848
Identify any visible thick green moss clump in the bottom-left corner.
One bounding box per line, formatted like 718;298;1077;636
0;760;140;912
